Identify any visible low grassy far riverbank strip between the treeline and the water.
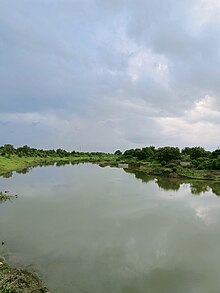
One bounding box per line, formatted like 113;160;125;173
0;154;220;182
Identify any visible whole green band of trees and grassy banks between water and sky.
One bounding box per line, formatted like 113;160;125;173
0;144;220;181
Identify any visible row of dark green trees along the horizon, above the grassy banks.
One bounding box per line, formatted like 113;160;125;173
0;144;220;170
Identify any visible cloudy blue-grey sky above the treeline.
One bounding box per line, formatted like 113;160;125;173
0;0;220;152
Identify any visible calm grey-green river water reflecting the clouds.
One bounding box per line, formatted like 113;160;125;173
0;164;220;293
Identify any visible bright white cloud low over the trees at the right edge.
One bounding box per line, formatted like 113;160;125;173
158;95;220;149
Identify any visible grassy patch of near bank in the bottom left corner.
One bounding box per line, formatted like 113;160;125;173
0;257;49;293
